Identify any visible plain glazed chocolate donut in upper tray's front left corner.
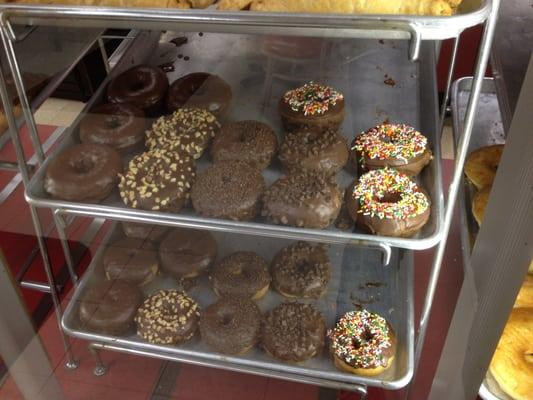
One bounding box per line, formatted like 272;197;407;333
44;144;122;202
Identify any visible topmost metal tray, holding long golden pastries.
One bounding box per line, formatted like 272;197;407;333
0;0;493;42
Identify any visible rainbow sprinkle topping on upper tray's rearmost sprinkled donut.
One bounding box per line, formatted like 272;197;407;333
283;82;344;116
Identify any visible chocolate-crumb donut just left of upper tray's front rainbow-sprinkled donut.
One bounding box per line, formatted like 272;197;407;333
261;172;342;229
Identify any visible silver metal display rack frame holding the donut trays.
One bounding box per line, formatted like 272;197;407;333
0;0;500;397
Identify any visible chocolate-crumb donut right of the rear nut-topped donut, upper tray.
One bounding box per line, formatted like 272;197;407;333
211;121;278;170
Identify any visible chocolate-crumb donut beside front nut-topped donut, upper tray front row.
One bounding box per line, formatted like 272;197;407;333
191;161;265;221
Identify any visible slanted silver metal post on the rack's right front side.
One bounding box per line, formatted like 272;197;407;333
415;0;500;394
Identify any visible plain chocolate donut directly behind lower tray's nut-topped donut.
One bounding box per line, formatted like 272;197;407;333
159;228;217;279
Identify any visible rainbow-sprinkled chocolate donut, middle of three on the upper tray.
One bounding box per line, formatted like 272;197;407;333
351;124;433;176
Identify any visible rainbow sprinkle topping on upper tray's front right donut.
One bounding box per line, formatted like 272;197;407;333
352;168;429;219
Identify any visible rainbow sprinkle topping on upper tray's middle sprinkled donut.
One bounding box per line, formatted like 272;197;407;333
352;124;428;163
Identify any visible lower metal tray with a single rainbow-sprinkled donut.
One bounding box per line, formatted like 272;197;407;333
62;223;414;389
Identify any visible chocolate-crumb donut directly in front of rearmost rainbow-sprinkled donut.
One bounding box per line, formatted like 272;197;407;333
279;129;348;175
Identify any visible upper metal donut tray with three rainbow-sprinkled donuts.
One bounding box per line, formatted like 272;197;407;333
26;33;443;249
